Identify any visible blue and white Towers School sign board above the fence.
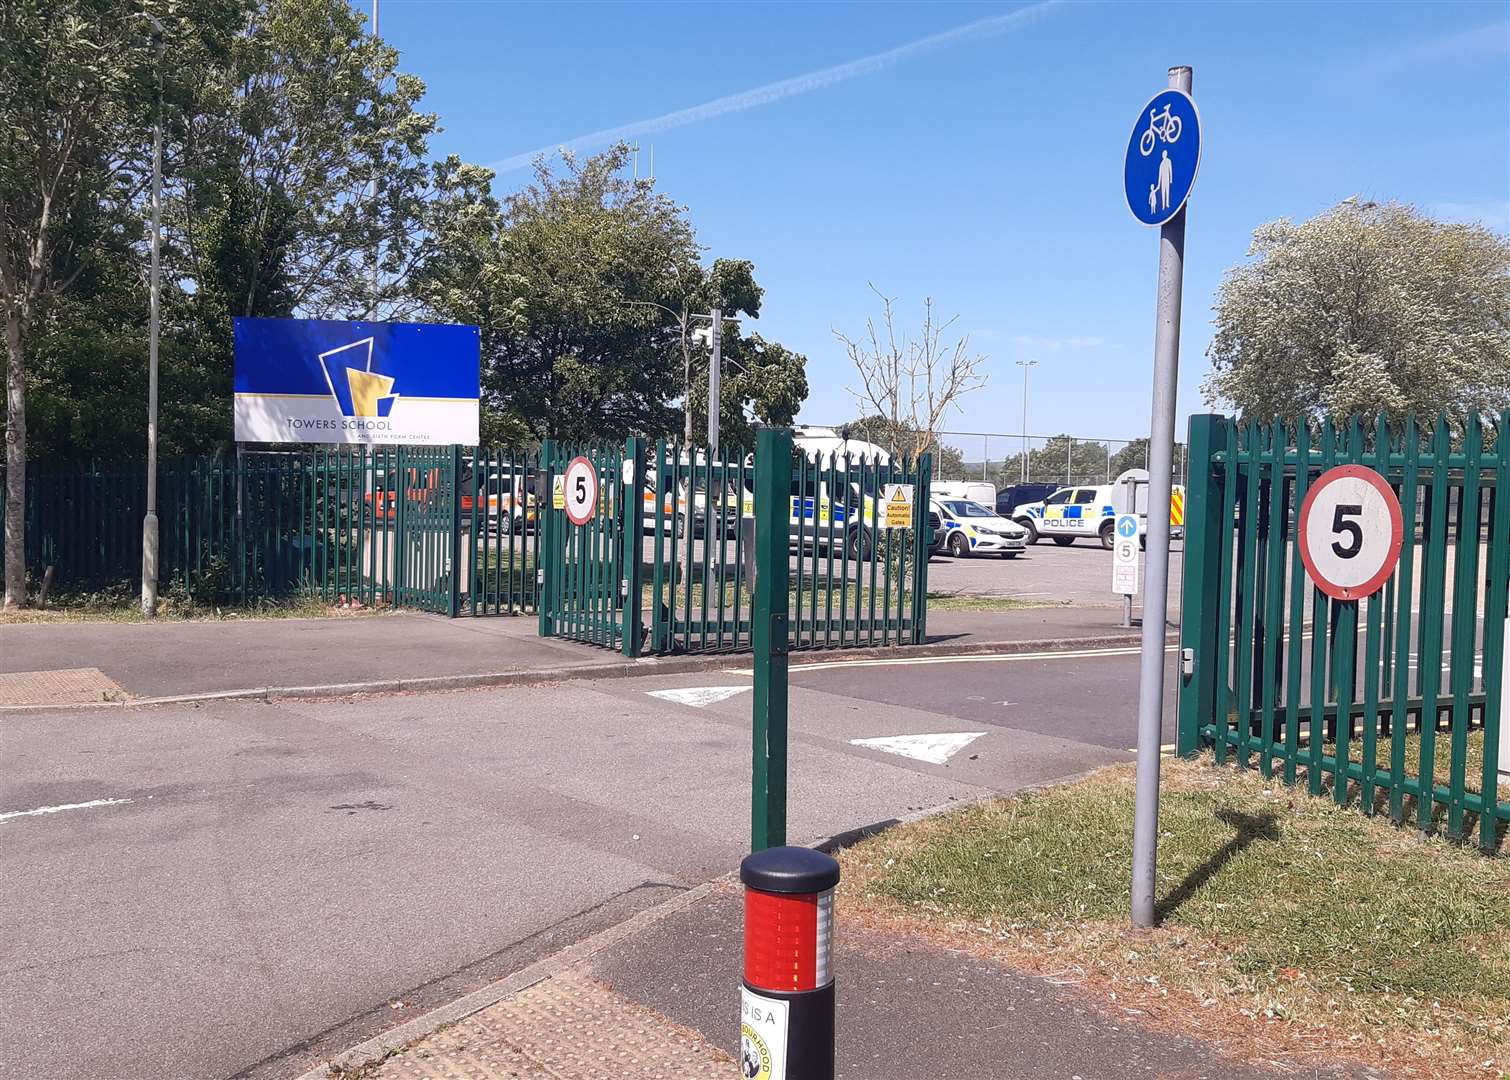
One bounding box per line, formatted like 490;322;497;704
234;319;480;446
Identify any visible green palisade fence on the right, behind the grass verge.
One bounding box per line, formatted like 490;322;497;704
1178;414;1510;852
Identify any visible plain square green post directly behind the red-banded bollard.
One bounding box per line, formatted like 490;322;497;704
750;427;791;852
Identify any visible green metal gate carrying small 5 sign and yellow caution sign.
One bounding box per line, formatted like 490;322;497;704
539;440;932;656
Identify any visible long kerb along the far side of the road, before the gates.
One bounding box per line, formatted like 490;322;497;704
0;633;1175;713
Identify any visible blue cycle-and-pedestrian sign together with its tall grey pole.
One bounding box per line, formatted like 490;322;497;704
1123;66;1200;927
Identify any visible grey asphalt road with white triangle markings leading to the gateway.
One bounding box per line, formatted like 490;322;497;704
0;651;1170;1080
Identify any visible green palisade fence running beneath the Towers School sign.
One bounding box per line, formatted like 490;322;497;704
0;447;539;615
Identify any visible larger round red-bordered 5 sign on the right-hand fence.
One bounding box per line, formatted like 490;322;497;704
1296;465;1404;600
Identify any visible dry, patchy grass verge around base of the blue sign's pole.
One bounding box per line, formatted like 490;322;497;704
843;760;1510;1080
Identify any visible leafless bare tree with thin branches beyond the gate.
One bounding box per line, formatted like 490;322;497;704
834;285;986;455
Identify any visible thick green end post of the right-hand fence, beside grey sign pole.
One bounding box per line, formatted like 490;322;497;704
1176;412;1232;757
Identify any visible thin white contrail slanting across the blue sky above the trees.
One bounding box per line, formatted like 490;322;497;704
488;0;1062;172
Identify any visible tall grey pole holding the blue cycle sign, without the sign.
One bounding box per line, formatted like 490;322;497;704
1133;66;1191;927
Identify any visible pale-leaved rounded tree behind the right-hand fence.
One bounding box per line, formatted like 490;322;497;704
1205;199;1510;420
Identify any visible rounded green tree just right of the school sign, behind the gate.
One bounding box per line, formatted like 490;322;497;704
417;145;808;444
